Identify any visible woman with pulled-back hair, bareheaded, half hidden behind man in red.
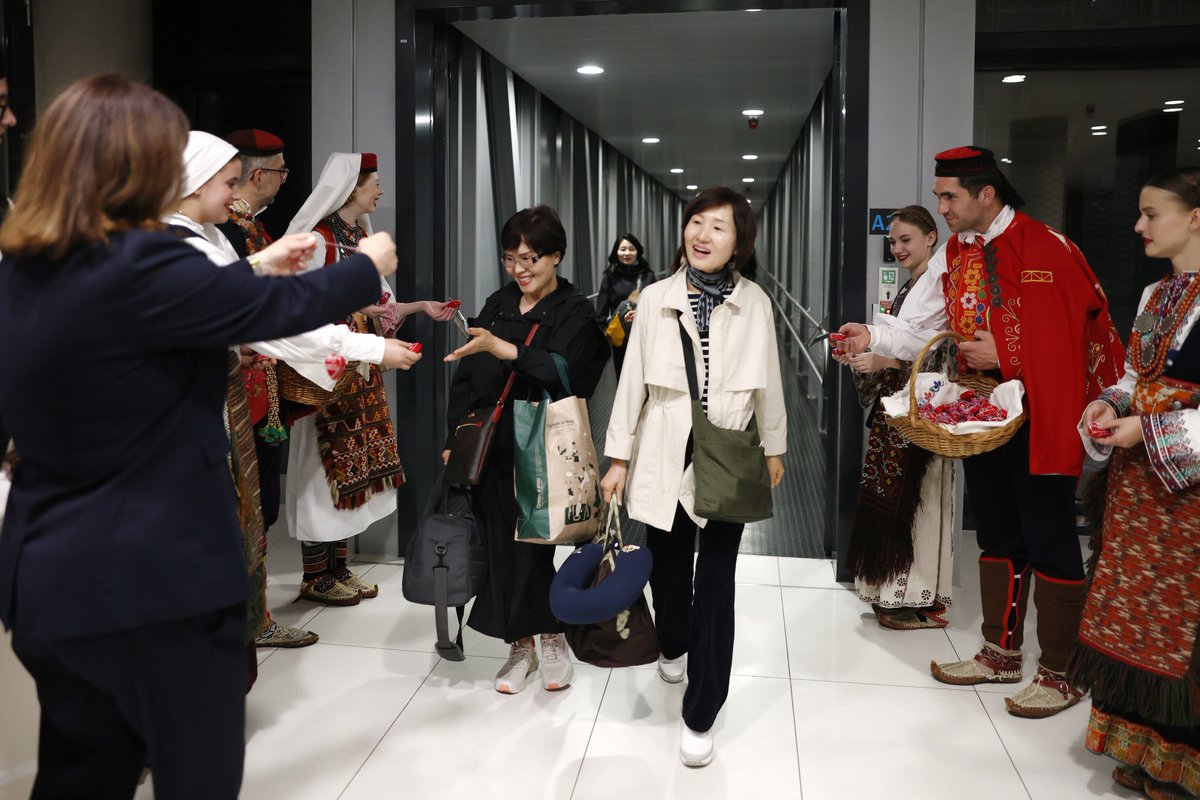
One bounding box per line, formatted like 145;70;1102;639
834;205;954;631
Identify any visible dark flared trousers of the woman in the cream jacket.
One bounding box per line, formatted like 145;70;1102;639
647;506;744;732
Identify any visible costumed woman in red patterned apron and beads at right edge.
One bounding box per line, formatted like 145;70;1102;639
1070;167;1200;798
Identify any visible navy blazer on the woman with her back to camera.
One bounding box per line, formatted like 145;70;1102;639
0;230;379;640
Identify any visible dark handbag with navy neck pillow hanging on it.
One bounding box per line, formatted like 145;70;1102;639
551;500;659;667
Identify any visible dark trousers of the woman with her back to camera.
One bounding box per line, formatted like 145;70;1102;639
12;604;246;800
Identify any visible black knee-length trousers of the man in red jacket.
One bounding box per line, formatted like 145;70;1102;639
962;423;1084;581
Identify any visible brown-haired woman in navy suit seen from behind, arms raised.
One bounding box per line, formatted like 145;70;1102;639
0;74;396;800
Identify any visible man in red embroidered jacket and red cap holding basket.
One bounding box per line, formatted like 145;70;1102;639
841;148;1124;717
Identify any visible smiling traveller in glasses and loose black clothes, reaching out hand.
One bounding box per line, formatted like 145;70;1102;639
443;205;608;694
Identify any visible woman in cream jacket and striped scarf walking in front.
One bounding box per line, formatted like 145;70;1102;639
601;186;787;766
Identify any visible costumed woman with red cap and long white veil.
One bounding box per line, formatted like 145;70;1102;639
284;152;454;606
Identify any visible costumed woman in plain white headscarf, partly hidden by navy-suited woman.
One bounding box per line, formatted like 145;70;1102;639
163;131;416;666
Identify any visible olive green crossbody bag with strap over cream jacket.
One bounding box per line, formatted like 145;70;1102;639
679;320;773;523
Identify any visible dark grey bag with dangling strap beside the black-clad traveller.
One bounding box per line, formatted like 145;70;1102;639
401;475;487;661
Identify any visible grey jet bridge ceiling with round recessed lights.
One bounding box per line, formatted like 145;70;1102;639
455;8;834;204
